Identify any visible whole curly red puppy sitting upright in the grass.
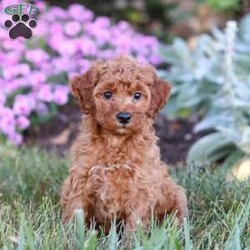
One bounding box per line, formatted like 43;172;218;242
61;56;187;231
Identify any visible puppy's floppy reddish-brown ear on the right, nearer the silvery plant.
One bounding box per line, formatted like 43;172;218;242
148;79;171;118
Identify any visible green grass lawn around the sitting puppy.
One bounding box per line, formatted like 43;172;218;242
0;148;250;250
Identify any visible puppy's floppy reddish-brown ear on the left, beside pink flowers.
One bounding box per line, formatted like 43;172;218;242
70;62;100;114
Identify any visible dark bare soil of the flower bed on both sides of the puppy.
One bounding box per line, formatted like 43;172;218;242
26;105;200;164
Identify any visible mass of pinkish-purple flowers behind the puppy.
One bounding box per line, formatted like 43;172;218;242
0;0;160;144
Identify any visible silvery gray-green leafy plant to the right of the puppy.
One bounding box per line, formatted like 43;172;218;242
159;15;250;168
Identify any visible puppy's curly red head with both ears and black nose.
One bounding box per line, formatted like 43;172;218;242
71;56;170;134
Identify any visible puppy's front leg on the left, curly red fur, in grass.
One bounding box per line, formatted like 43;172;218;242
60;167;91;222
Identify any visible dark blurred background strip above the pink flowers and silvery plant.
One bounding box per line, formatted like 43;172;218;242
48;0;250;41
